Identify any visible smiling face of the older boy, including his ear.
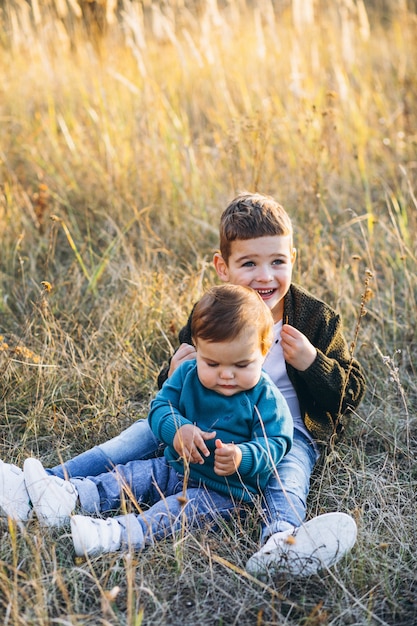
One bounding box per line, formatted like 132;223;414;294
213;235;296;323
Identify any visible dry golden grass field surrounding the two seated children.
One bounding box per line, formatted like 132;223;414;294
0;0;417;626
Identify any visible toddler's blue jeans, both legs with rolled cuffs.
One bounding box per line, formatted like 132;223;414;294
71;457;238;549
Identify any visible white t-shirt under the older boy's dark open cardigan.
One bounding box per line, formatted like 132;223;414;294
264;320;313;441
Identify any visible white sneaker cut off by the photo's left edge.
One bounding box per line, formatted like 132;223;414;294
0;461;32;522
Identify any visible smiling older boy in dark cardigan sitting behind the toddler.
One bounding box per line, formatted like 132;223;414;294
0;193;365;575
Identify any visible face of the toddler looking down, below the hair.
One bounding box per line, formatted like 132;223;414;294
196;328;264;396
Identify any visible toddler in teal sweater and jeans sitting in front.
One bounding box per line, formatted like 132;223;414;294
20;285;293;555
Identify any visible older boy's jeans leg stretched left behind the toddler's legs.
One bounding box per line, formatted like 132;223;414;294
47;419;164;478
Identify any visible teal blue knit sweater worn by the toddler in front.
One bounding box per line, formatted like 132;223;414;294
149;360;293;502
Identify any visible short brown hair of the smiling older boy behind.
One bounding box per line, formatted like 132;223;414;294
219;193;293;263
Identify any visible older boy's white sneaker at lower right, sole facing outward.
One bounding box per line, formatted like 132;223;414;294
246;513;357;578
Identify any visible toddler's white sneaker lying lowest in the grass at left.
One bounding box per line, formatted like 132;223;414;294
71;515;122;556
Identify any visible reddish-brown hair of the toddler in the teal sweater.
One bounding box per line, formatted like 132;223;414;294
191;284;274;356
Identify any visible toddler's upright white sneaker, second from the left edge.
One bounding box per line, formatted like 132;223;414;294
23;458;78;526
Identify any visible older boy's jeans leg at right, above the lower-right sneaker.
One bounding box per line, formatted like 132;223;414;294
261;428;320;543
